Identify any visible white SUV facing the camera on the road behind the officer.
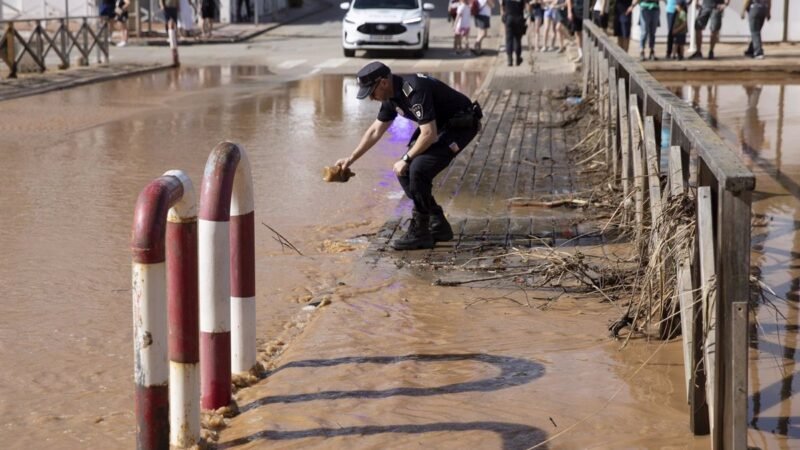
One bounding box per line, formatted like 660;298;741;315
339;0;434;57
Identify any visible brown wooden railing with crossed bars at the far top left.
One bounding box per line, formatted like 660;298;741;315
0;17;111;78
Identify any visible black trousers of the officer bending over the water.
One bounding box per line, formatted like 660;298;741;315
397;125;480;215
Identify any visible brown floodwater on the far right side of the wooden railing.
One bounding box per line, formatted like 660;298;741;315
667;77;800;449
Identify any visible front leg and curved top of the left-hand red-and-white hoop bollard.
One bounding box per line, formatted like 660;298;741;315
131;171;199;449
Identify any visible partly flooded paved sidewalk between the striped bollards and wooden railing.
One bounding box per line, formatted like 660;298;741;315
209;46;692;449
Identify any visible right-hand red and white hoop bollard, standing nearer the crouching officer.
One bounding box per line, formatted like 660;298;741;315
198;142;256;409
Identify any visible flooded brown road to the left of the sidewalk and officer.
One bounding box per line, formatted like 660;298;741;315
0;66;482;448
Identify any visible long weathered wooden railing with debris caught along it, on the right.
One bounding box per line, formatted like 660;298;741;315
583;21;755;450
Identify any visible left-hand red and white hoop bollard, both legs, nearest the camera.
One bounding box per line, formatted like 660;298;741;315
131;171;200;449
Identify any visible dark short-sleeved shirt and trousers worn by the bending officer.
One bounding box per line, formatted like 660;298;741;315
378;74;480;215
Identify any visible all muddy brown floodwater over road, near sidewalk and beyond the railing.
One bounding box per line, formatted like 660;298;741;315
0;67;800;449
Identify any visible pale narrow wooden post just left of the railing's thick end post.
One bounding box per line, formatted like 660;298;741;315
697;186;716;450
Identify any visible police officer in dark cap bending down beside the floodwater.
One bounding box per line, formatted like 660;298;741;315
336;61;482;250
